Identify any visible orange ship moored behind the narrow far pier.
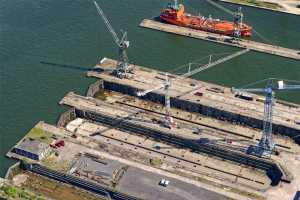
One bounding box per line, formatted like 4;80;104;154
160;1;252;37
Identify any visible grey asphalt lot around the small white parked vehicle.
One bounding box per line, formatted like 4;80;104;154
117;167;227;200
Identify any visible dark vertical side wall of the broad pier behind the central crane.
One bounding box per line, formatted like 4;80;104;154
103;80;300;144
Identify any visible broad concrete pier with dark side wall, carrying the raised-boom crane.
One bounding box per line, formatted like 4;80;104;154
88;59;300;142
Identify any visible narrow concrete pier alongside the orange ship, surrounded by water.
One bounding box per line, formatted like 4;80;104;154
140;19;300;60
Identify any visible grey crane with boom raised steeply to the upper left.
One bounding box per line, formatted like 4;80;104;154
94;1;130;78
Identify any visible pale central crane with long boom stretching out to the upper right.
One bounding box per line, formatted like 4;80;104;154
136;49;250;128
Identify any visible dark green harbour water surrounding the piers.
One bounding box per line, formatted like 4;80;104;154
0;0;300;176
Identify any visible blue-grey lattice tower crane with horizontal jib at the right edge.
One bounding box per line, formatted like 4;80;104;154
232;78;300;157
